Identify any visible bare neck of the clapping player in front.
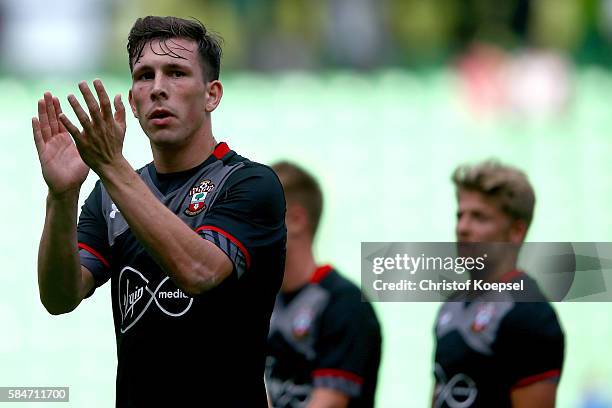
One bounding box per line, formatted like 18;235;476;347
151;132;217;173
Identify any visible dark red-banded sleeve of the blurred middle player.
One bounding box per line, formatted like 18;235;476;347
312;291;381;398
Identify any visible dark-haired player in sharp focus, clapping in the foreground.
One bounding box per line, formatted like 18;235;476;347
32;17;286;408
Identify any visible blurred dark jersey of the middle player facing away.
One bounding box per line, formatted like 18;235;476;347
266;265;382;408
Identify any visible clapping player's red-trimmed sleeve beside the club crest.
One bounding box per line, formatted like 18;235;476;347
196;164;287;278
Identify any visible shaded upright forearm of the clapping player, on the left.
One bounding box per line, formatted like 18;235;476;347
38;190;82;314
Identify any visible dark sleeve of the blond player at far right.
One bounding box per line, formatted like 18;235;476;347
495;302;565;388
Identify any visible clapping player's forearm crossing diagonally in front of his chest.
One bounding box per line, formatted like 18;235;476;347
99;160;224;295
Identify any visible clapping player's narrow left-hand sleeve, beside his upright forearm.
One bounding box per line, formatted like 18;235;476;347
77;181;111;296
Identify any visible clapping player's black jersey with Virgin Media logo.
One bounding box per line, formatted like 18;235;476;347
77;143;286;408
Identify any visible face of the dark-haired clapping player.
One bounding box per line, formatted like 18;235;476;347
129;38;218;147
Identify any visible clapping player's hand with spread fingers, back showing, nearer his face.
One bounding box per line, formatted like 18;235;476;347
59;79;126;175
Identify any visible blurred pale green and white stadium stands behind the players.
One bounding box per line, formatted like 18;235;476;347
0;0;612;408
